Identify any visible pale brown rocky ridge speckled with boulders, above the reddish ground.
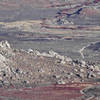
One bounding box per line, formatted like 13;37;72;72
0;41;100;87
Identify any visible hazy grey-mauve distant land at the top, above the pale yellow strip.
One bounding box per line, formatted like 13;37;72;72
0;0;100;22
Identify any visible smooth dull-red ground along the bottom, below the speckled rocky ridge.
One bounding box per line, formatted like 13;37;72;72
0;83;100;100
